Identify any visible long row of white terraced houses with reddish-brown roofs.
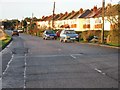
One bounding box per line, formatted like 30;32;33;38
36;4;118;31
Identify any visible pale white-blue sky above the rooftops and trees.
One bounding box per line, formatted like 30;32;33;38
0;0;120;20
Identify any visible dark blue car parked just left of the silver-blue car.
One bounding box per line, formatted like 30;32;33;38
42;30;57;40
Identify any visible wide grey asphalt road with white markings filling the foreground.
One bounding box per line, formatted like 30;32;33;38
2;30;118;88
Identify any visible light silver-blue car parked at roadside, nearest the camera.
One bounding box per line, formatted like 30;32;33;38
60;30;79;42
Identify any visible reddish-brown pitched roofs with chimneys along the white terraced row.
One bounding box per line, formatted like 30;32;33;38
41;4;120;21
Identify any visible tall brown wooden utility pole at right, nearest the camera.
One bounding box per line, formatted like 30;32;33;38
101;0;105;44
